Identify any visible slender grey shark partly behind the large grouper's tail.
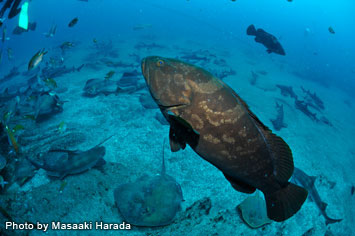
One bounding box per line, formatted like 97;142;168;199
292;167;342;225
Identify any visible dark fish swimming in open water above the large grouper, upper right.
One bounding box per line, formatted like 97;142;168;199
247;25;286;56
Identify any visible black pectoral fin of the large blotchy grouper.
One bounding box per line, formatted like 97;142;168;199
168;114;200;152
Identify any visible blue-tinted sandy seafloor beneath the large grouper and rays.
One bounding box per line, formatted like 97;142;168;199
1;35;355;236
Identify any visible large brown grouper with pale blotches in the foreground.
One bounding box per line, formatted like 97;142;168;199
141;56;308;222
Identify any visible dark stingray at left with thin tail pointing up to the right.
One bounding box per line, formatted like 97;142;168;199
30;136;112;179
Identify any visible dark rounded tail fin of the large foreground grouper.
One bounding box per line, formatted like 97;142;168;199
265;183;308;222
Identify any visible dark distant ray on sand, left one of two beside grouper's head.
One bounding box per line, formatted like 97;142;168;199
83;79;120;97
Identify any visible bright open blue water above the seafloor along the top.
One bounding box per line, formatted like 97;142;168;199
2;0;355;93
